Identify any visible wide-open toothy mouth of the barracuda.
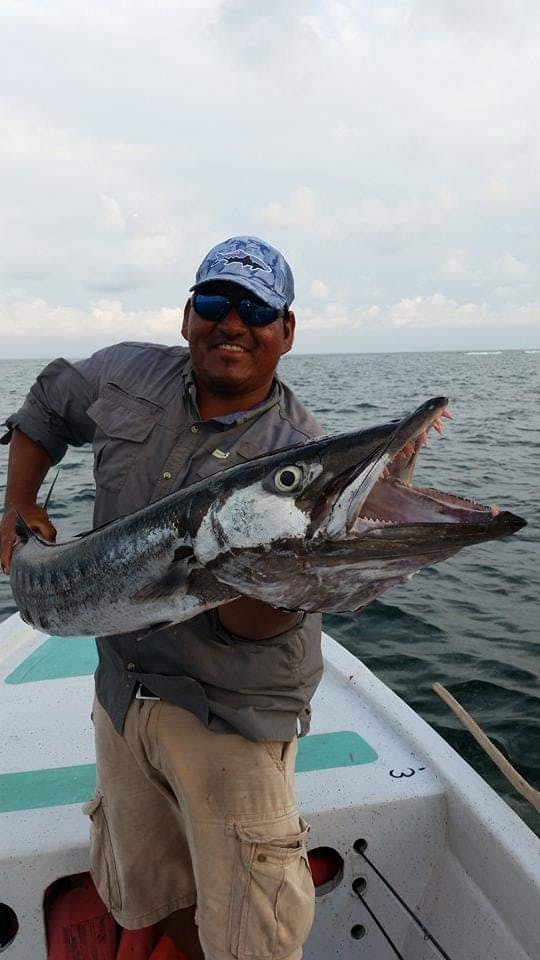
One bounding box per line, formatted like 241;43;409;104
316;397;525;540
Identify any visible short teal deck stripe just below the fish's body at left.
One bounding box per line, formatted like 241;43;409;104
6;637;97;683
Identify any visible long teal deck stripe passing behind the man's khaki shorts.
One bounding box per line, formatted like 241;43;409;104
0;730;377;813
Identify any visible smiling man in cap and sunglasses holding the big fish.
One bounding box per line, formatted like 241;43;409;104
1;237;322;960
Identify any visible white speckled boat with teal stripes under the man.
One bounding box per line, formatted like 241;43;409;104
0;615;540;960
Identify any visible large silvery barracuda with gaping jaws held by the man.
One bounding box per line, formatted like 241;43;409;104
11;397;525;636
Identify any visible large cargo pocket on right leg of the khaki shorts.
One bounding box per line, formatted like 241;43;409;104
229;817;315;960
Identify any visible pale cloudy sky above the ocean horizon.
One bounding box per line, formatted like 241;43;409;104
0;0;540;358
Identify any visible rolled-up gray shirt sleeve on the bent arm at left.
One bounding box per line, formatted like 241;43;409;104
2;353;102;464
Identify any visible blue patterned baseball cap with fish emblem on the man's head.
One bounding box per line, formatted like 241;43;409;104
190;237;294;310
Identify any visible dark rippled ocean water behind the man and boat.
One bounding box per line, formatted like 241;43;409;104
0;351;540;832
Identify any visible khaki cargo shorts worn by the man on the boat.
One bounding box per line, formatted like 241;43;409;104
83;700;314;960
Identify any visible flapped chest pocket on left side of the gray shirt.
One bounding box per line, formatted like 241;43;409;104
88;383;163;493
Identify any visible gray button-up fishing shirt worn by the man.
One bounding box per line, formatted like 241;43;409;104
7;343;322;740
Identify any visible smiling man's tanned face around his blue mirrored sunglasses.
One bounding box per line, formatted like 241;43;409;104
182;282;295;398
